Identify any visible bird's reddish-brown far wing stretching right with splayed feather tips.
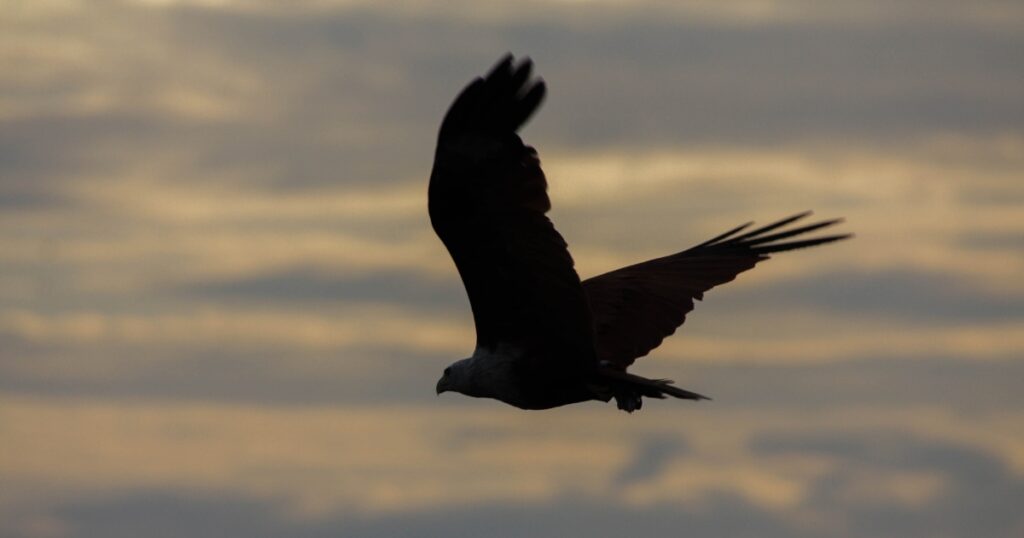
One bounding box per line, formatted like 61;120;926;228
583;211;850;369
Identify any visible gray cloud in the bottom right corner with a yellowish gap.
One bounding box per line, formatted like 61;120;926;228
754;432;1024;537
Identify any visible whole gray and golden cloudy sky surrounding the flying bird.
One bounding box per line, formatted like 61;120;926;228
0;0;1024;538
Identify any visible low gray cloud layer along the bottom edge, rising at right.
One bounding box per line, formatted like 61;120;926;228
9;432;1024;538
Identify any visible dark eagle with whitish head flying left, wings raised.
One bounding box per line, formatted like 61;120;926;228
428;54;850;413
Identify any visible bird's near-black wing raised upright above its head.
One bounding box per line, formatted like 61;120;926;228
429;55;595;370
